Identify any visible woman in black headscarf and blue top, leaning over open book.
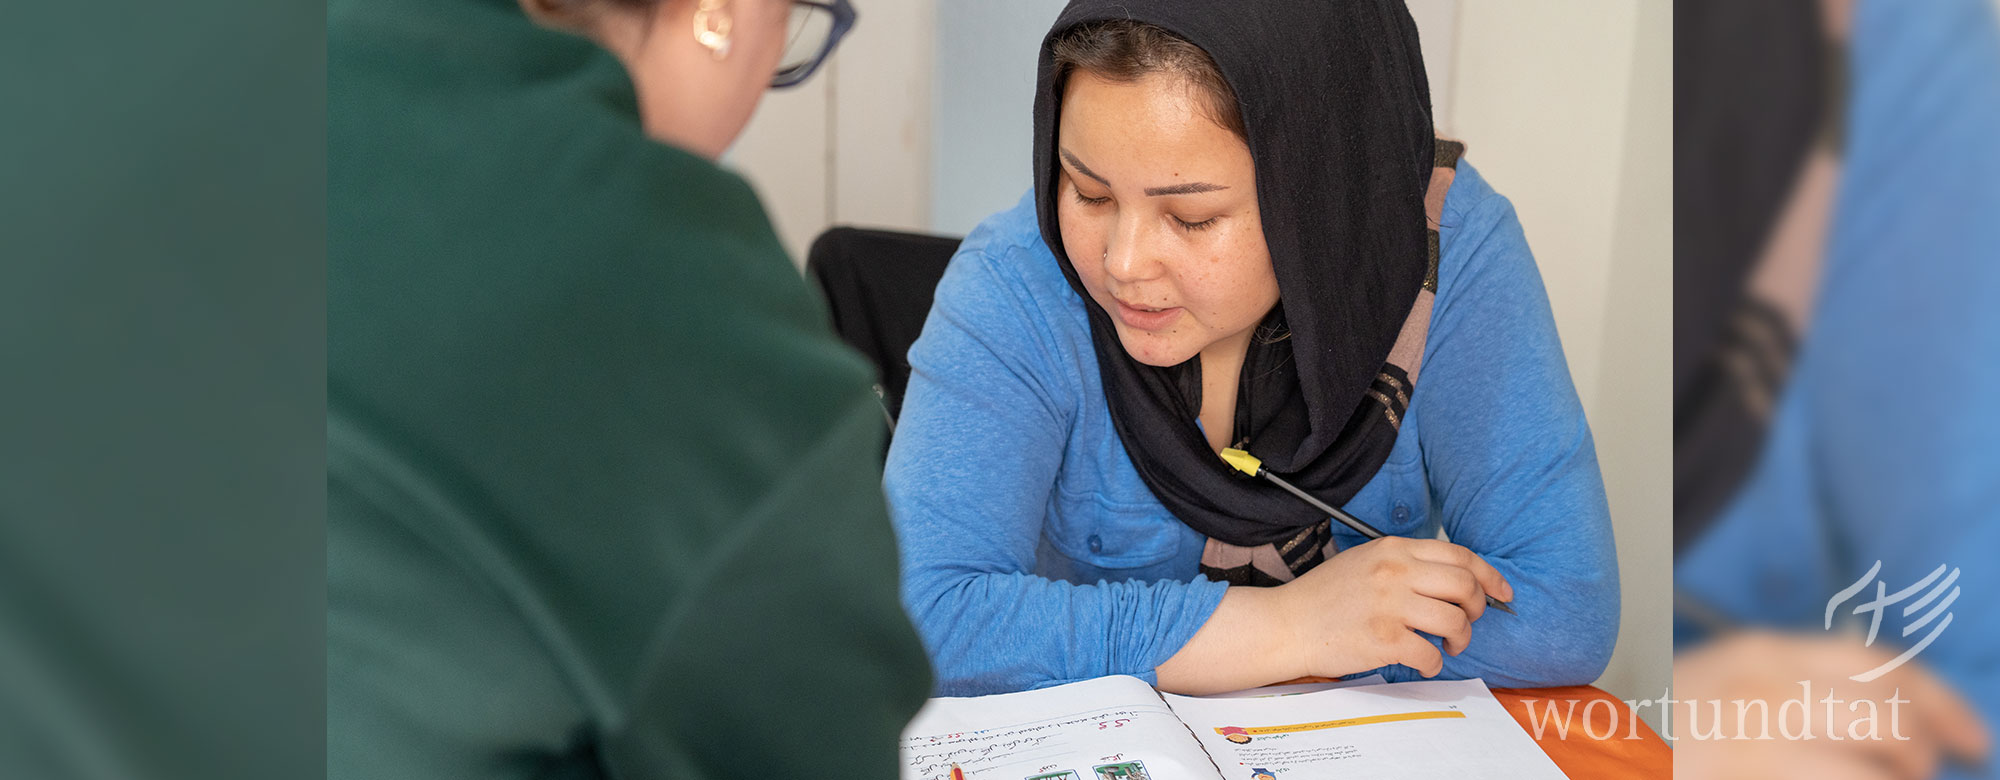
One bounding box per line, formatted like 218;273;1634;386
886;0;1618;696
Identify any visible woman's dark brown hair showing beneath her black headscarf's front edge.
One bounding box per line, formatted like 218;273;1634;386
1048;20;1248;138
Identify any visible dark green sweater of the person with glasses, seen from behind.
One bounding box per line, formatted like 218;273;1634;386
326;0;930;780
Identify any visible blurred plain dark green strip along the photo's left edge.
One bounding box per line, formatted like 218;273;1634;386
0;0;326;778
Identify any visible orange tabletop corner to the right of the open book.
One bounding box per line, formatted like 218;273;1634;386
1494;686;1674;780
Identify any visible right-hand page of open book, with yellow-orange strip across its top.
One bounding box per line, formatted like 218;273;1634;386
1162;680;1564;780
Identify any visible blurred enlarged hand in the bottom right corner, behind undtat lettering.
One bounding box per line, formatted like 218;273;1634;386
1674;632;1992;780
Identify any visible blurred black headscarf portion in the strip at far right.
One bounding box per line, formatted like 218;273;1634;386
1674;0;1844;550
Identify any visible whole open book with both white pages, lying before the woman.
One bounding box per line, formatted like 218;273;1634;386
902;676;1564;780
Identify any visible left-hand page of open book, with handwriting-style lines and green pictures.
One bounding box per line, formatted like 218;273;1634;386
898;676;1216;780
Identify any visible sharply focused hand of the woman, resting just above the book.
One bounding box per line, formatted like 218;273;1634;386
1274;536;1514;678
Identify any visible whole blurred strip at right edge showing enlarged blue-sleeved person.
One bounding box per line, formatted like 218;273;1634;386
1674;0;2000;778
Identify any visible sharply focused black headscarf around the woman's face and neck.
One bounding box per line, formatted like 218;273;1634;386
1034;0;1434;546
